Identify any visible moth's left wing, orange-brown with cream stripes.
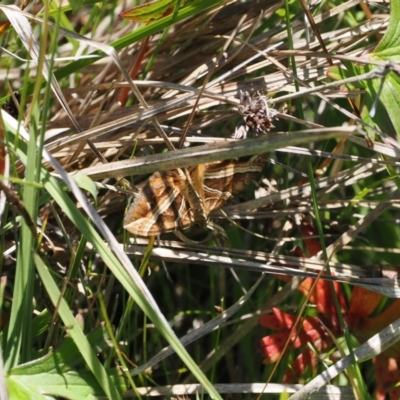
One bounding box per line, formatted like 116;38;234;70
124;170;194;236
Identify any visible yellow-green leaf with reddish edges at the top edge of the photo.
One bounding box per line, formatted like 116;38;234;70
119;0;184;23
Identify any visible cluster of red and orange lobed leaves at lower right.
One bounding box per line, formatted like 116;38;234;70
259;223;400;392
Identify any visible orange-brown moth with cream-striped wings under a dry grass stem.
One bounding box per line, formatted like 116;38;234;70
124;154;267;236
